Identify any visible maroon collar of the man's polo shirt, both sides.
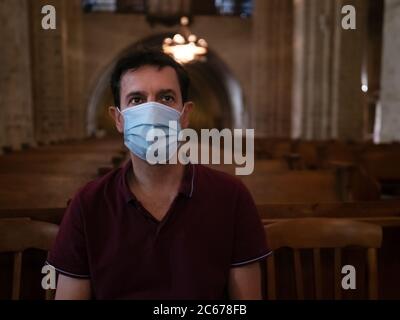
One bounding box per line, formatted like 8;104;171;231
120;159;195;203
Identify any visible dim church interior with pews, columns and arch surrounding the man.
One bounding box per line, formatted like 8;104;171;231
0;0;400;300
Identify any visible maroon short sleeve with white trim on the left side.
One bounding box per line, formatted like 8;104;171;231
47;193;90;278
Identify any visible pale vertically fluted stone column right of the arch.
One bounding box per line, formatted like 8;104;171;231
292;0;334;139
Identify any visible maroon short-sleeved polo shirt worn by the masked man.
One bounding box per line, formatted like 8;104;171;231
48;161;269;299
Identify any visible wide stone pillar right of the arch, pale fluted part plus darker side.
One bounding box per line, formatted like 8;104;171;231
292;0;367;140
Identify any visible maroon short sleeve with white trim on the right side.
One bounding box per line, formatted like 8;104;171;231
231;183;271;267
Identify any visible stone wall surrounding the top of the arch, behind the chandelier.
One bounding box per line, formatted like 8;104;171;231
83;13;252;134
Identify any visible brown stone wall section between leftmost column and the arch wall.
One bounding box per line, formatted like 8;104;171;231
30;0;85;143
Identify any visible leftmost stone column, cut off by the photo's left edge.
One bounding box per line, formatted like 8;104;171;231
0;0;34;153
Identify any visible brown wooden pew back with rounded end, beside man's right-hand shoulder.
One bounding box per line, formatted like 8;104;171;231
208;160;380;204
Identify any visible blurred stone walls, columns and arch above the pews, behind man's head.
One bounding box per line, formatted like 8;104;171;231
0;0;400;145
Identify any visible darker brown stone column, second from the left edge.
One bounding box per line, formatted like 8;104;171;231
29;0;69;143
